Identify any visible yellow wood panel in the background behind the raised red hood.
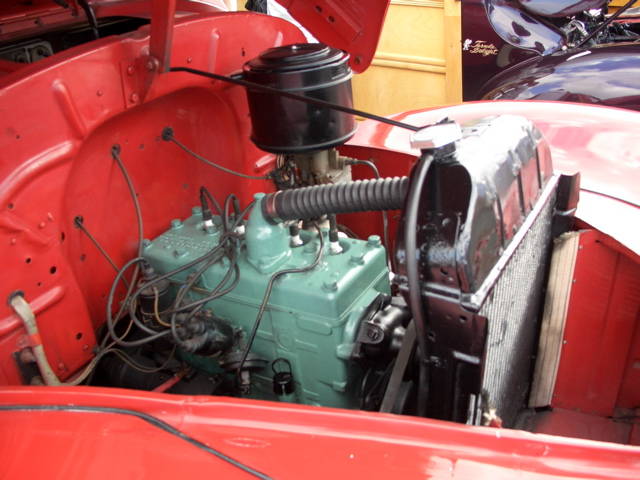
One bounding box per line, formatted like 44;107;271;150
353;0;462;115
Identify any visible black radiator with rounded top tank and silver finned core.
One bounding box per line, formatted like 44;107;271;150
397;115;558;426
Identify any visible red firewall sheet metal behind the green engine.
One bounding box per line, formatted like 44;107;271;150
0;13;304;384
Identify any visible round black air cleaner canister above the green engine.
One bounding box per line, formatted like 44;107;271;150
243;43;356;153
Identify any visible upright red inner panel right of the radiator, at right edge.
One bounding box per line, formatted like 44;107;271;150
552;231;640;416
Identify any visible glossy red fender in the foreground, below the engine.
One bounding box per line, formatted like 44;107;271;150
0;387;640;480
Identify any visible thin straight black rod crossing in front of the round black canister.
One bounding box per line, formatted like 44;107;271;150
169;67;423;132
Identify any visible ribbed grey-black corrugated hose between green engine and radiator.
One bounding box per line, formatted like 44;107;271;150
262;177;409;221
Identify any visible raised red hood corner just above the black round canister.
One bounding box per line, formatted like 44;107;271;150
278;0;390;73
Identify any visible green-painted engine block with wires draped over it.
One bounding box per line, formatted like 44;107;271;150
144;194;389;408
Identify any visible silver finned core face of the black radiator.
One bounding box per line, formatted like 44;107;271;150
480;186;555;427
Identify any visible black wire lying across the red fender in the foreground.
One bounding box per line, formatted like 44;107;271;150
0;405;271;480
